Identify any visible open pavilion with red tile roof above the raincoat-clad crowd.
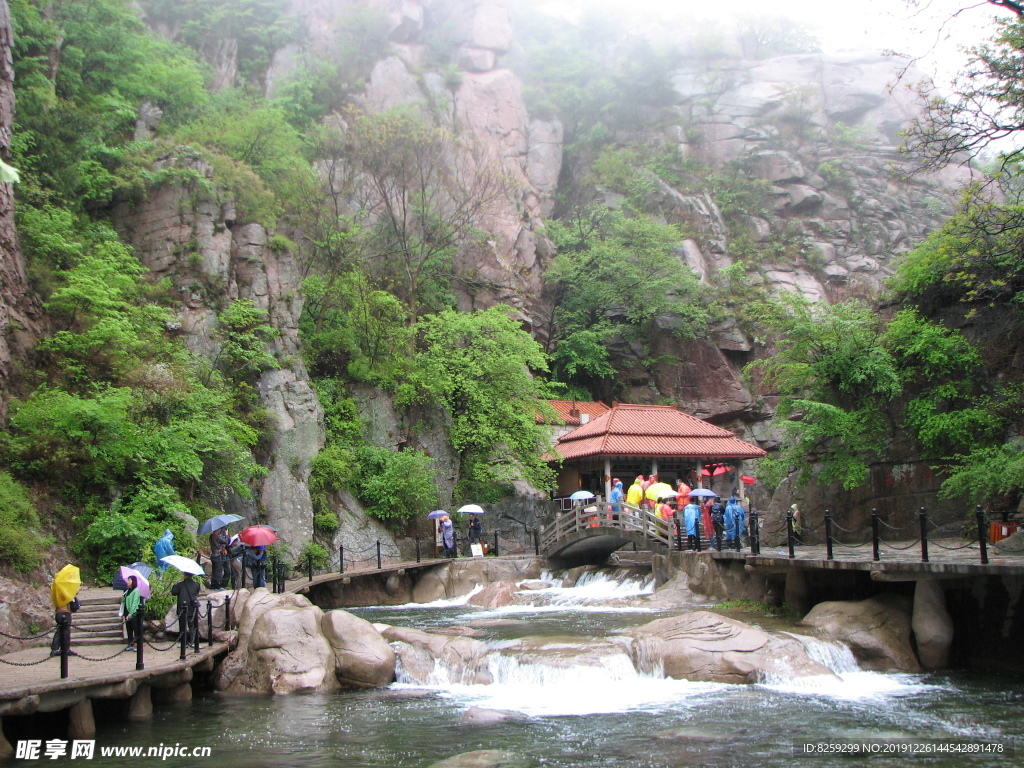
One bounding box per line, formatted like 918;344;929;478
554;402;767;499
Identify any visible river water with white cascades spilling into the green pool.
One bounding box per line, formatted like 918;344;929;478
39;573;1024;768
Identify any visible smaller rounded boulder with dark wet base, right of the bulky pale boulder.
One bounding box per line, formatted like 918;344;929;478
322;610;395;688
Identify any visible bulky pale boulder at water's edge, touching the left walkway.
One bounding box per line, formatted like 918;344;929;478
217;588;338;693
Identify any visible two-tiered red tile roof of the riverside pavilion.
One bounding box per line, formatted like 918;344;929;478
555;403;767;461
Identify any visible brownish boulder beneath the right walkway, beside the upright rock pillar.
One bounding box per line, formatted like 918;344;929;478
802;595;921;672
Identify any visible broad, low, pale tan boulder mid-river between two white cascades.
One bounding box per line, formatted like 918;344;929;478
627;610;839;683
